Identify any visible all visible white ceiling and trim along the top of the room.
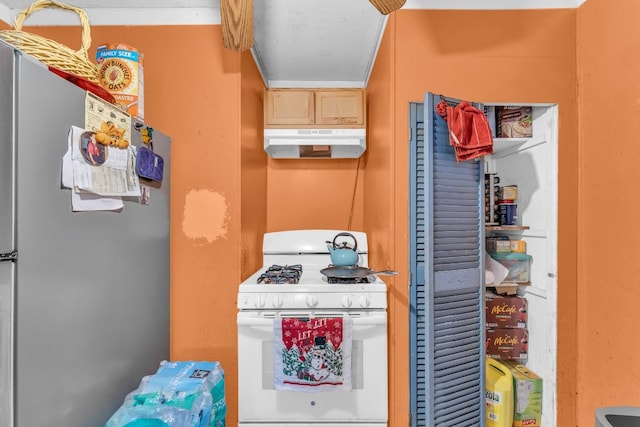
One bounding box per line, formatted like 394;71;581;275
0;0;585;87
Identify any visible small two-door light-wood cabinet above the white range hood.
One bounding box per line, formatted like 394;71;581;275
264;89;366;128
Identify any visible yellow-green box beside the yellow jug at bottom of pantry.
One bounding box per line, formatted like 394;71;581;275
502;360;542;427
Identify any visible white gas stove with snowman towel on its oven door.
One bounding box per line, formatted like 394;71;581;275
237;230;388;427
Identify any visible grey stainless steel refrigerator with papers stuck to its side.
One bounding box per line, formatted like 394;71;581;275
0;41;170;427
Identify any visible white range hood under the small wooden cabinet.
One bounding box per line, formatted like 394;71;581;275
264;128;367;159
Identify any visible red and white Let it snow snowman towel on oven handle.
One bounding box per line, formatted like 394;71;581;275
273;316;352;392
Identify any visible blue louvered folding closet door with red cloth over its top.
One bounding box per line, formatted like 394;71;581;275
410;93;484;427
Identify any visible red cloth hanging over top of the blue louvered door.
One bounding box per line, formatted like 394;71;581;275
436;99;493;161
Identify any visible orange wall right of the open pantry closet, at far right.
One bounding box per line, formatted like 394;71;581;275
575;0;640;426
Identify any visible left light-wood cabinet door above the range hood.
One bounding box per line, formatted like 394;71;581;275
264;89;315;126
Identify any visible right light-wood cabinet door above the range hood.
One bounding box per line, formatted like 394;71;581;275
315;89;365;126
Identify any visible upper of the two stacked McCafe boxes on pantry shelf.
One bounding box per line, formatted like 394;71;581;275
484;292;527;329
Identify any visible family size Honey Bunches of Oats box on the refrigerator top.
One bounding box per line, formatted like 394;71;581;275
96;43;144;120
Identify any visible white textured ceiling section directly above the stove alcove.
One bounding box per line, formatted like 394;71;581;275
251;0;387;88
